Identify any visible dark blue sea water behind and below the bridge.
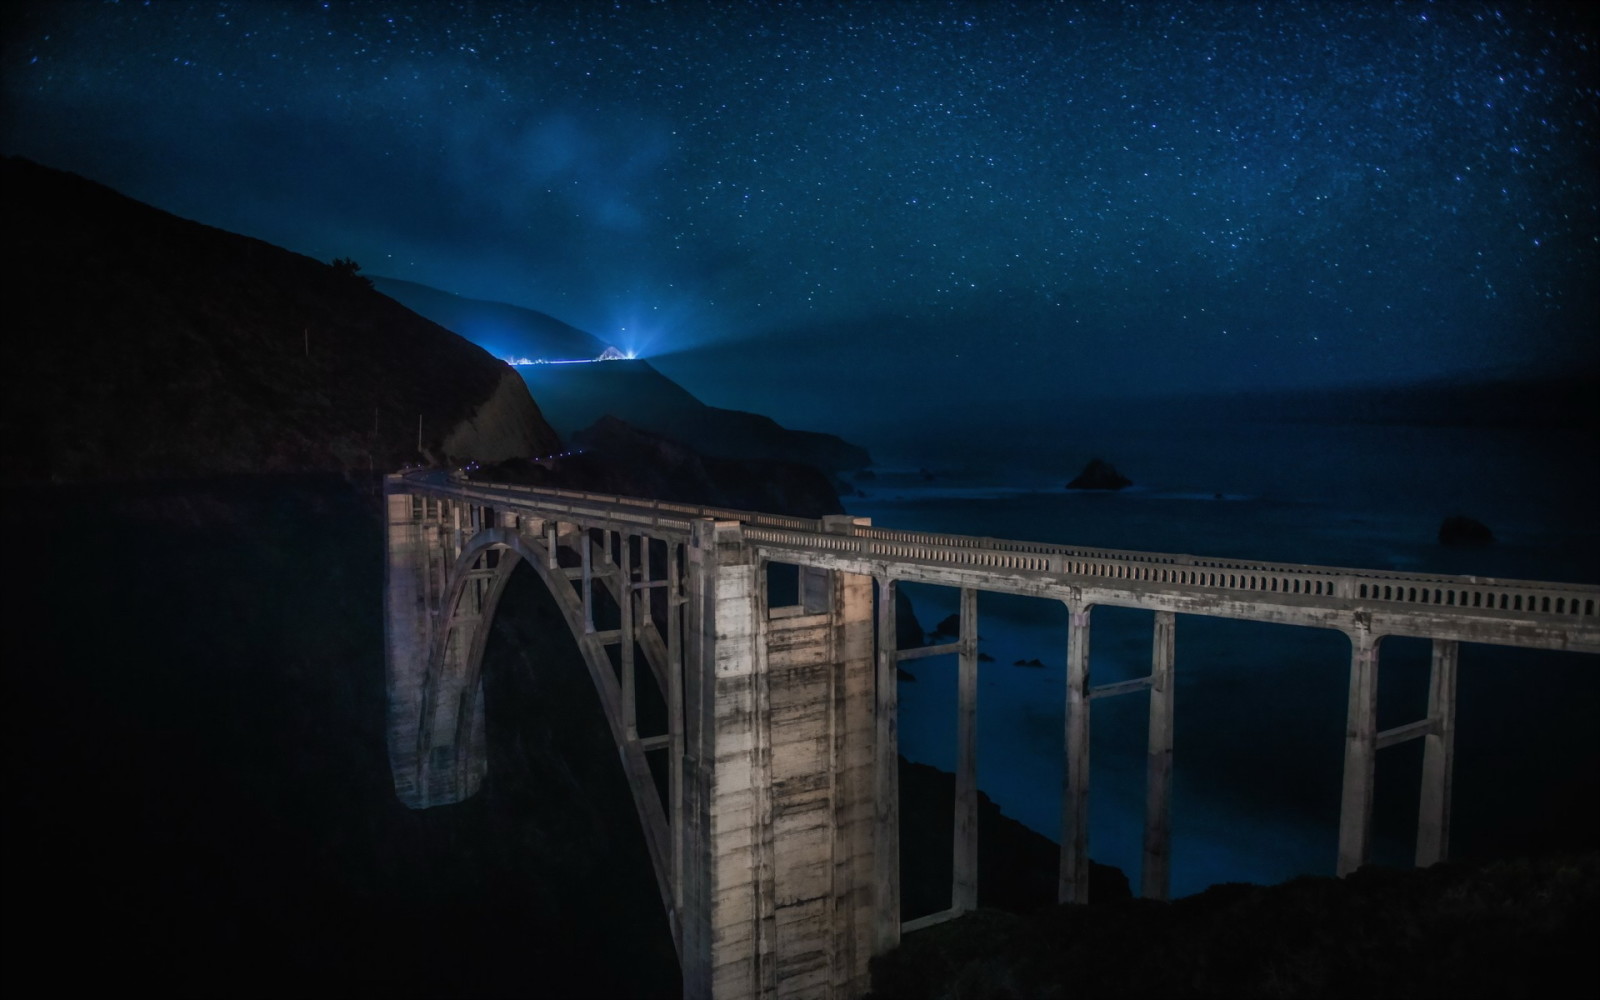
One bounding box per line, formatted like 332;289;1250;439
846;424;1600;896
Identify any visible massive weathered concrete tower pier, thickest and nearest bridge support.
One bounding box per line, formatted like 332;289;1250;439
669;520;876;1000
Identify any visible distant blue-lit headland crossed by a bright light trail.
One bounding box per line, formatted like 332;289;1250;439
363;278;872;472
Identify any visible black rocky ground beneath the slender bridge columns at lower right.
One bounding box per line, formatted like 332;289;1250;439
872;853;1600;1000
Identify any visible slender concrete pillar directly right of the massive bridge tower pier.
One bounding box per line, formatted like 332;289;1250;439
872;578;901;955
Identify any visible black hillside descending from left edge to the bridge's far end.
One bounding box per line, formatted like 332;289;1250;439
0;158;557;482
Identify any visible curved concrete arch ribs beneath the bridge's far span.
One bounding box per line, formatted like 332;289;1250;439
418;526;677;925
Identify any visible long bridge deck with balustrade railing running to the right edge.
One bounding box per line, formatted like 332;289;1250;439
405;474;1600;653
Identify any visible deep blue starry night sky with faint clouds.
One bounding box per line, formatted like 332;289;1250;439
3;0;1600;429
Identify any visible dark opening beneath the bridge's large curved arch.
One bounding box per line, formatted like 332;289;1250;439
478;563;682;997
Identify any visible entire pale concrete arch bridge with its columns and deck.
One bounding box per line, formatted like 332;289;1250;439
386;472;1600;1000
